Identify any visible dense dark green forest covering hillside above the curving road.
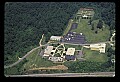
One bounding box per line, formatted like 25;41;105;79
4;2;115;65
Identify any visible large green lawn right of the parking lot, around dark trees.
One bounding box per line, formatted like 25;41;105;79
72;19;110;43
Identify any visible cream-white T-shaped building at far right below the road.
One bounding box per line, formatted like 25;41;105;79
90;43;106;53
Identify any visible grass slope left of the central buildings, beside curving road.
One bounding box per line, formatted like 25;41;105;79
23;49;55;69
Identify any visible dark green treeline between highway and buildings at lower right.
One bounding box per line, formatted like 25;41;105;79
65;61;115;73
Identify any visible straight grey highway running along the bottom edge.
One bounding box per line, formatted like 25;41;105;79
5;72;115;77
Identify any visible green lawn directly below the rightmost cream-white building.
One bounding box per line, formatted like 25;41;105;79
83;48;107;62
